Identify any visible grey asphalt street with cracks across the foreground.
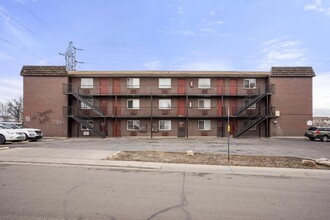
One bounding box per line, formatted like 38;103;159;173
0;164;330;220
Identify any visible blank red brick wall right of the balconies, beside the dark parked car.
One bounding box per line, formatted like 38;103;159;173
270;77;313;136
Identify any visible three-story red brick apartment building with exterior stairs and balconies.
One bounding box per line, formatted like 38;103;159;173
21;66;315;137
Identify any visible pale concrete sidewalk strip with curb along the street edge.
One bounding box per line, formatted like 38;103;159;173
0;156;330;180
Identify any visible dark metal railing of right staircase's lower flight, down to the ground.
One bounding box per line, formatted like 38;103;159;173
235;106;275;137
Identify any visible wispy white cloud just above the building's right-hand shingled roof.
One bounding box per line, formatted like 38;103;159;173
257;39;307;70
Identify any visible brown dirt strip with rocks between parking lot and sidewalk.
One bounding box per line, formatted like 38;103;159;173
109;151;330;169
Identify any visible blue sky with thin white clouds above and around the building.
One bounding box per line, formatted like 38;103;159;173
0;0;330;116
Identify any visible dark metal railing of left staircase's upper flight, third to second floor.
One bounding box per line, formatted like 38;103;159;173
62;84;105;117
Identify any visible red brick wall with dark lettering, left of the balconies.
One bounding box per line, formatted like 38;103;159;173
23;76;67;137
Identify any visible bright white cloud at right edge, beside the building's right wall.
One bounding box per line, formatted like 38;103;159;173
313;72;330;117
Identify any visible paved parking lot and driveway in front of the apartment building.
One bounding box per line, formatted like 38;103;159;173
0;137;330;159
